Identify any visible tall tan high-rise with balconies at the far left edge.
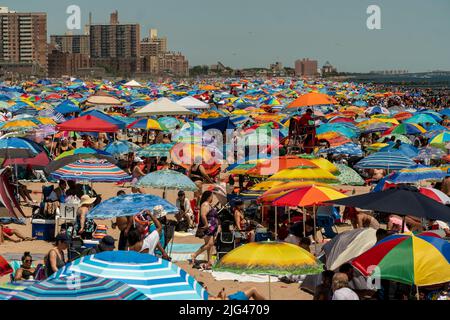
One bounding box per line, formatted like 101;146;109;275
0;7;47;74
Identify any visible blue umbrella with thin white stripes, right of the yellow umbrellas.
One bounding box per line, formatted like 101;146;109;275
355;151;415;170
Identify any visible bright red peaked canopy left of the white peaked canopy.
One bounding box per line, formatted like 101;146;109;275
56;114;119;132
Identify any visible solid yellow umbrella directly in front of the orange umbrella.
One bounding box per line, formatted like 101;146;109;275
268;167;338;182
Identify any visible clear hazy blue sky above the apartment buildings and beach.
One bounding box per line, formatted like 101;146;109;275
0;0;450;72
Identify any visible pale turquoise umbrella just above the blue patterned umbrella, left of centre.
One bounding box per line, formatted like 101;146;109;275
137;169;197;191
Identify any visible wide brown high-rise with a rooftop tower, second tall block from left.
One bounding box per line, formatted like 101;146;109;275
89;11;141;75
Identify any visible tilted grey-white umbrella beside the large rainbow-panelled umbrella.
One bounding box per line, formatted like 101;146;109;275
322;228;377;271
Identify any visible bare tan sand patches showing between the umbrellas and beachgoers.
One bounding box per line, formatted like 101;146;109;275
0;183;367;300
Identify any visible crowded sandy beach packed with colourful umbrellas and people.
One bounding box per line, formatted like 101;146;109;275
0;78;450;300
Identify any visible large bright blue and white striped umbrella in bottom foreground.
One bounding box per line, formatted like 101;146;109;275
52;251;208;300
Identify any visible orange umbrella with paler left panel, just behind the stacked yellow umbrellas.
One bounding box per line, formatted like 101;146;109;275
247;156;318;176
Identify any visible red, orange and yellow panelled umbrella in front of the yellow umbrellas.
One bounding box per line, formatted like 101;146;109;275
272;185;347;207
